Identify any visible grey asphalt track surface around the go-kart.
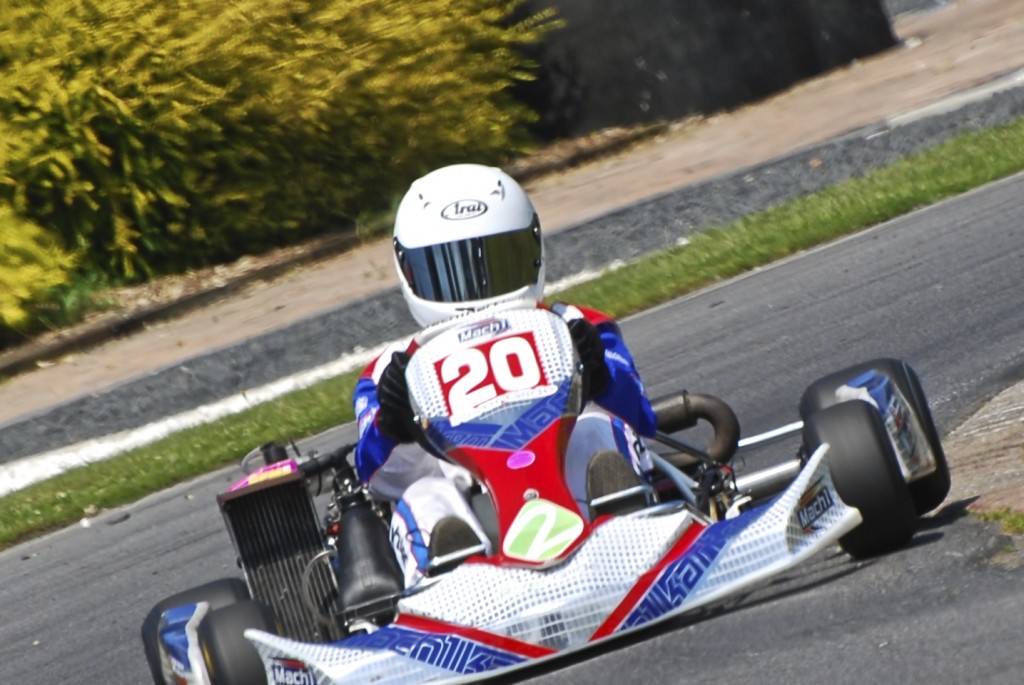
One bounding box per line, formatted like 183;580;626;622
0;176;1024;685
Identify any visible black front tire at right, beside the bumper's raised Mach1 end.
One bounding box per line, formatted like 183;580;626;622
804;400;918;559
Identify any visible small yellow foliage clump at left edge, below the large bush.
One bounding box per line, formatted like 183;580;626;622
0;202;75;340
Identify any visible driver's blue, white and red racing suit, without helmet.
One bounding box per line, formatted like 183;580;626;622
353;304;656;587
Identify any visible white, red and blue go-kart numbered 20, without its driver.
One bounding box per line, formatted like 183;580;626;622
142;306;949;685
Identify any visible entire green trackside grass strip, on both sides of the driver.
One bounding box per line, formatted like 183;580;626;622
6;114;1024;548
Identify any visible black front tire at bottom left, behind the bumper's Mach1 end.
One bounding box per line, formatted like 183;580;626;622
198;599;278;685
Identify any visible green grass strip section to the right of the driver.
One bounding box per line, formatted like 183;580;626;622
558;119;1024;317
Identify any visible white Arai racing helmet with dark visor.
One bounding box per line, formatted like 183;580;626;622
394;164;544;326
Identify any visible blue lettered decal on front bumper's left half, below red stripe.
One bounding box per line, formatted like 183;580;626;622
336;626;526;674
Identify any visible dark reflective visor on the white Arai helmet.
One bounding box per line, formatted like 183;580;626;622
394;221;541;302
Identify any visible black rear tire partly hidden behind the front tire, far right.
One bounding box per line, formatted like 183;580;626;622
800;358;951;515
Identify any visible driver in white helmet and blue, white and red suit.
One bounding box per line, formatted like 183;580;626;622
353;164;655;587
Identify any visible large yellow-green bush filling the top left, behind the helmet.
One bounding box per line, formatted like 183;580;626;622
0;0;554;290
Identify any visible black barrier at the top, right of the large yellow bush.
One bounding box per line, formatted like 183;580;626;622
518;0;896;139
